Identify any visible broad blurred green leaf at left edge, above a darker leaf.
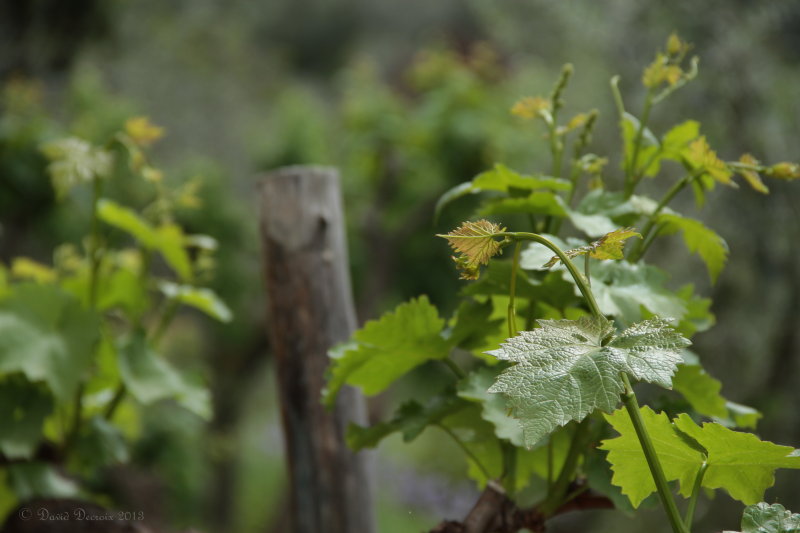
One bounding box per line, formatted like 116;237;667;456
0;285;100;402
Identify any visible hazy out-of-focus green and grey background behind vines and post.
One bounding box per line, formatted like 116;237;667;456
0;0;800;533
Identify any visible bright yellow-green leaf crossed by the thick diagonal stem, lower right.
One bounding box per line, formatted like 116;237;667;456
599;406;705;508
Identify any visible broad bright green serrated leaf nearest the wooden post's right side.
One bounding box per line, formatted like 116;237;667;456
323;296;451;406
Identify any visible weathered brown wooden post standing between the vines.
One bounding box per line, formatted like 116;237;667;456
261;166;375;533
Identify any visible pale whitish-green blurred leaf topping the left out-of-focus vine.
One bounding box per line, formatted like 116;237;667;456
42;137;114;198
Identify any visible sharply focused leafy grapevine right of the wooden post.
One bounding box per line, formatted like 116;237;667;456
324;35;800;533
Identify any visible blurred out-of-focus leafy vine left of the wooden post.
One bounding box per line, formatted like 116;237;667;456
0;117;232;500
